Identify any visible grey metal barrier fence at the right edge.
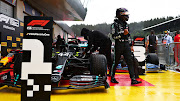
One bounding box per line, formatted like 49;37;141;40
156;42;180;70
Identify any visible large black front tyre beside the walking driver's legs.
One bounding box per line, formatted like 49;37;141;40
90;54;107;76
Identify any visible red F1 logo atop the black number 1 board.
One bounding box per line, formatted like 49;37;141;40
27;20;50;26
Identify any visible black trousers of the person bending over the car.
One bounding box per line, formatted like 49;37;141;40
99;39;113;68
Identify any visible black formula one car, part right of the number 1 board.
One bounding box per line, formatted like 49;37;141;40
51;38;109;89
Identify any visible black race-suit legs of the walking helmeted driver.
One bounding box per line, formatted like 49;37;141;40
111;40;135;78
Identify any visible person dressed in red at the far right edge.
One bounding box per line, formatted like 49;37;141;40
174;31;180;66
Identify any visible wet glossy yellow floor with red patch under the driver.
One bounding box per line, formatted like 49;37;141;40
0;71;180;101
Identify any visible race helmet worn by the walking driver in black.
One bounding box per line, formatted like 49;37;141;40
116;8;129;21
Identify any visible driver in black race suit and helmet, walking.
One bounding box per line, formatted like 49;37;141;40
111;8;141;84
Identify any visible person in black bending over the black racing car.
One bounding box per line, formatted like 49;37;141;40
81;28;112;71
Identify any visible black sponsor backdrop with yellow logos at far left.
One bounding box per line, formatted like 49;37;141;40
0;13;23;56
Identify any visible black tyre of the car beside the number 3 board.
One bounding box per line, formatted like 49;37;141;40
146;53;159;65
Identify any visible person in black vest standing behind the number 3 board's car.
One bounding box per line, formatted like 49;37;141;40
146;30;158;53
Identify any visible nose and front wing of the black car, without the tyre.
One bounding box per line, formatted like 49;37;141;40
51;52;108;89
